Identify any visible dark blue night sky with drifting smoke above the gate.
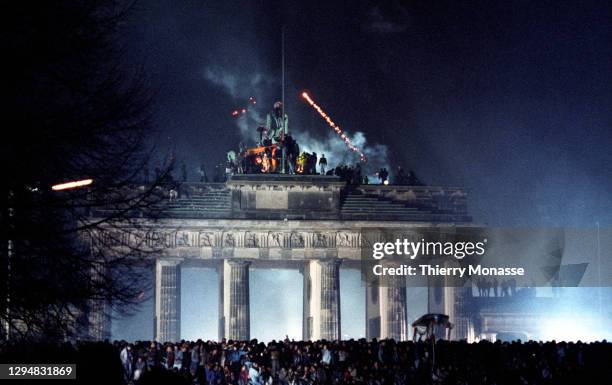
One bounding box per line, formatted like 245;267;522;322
115;1;612;340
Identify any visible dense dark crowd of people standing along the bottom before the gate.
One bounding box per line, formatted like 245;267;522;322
115;339;612;385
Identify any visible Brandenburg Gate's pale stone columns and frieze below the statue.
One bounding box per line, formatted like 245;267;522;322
89;174;471;341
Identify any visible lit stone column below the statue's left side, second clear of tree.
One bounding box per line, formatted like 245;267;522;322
219;259;251;341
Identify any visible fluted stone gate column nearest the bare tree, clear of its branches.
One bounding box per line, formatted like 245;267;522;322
154;258;181;342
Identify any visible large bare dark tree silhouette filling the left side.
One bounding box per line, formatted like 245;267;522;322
0;1;172;339
